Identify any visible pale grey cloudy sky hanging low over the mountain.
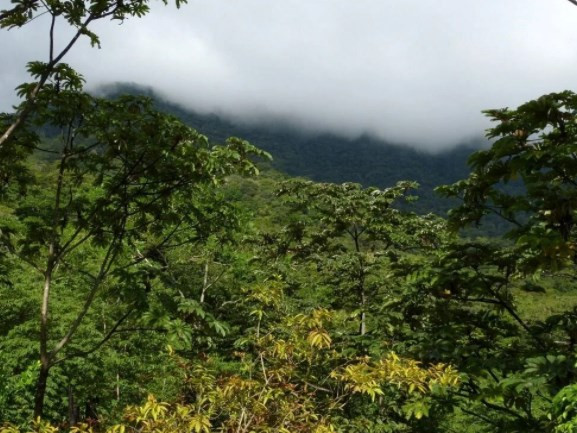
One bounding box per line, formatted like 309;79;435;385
0;0;577;149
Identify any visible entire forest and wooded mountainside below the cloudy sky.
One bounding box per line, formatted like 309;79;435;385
0;0;577;433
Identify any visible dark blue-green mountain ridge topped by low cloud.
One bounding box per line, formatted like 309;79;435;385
98;83;483;214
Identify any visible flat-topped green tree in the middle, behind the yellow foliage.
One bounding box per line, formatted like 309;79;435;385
280;181;443;336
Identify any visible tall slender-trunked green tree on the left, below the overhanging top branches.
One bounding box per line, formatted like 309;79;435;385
1;77;265;416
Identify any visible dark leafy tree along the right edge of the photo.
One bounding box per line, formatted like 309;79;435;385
427;91;577;431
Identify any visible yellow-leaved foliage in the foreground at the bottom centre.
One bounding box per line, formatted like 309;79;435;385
3;286;459;433
